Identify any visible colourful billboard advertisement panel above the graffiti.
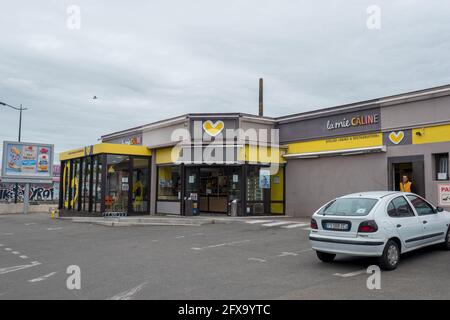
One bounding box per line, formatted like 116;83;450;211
2;141;54;182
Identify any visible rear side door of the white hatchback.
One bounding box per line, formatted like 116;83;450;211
387;196;423;248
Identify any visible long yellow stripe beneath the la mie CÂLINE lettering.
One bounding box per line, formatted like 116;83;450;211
287;132;383;154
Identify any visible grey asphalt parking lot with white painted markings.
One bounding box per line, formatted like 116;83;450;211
0;214;450;299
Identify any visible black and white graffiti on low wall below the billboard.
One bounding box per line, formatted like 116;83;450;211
0;184;59;202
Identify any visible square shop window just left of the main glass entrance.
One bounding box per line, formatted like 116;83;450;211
158;166;181;200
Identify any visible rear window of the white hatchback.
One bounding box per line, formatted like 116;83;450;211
319;198;378;216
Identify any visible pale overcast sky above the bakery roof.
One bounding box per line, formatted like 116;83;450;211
0;0;450;159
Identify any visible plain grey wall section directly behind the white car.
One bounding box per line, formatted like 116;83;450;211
286;153;388;217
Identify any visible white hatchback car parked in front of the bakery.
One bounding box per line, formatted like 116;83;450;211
309;191;450;270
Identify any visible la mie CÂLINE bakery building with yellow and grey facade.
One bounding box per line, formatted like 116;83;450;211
60;85;450;217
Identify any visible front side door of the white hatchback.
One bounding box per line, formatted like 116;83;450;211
406;194;447;243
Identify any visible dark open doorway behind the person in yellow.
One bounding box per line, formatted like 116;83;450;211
388;156;425;197
